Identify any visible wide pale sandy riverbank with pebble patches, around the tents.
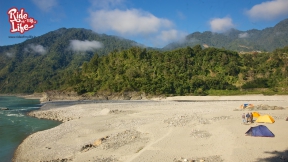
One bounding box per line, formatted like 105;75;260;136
14;95;288;162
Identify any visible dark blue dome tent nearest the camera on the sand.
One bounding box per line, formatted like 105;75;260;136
245;125;275;137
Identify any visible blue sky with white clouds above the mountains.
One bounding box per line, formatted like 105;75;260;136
0;0;288;50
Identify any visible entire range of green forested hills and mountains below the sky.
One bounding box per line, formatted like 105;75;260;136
0;19;288;95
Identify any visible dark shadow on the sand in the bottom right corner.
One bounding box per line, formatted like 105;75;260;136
257;149;288;162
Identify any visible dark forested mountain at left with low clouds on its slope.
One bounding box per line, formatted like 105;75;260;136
0;28;137;93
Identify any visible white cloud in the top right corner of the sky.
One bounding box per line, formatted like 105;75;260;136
246;0;288;20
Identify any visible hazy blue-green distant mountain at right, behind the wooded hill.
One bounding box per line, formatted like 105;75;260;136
163;19;288;52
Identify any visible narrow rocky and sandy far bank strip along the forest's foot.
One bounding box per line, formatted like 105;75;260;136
0;90;288;103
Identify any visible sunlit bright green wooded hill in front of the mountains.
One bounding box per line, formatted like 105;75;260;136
65;45;288;95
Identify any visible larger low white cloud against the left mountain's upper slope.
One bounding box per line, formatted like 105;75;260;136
69;40;103;51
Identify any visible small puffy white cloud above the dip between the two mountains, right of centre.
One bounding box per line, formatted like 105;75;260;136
209;17;235;33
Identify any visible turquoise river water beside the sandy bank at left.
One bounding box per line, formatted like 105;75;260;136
0;96;60;162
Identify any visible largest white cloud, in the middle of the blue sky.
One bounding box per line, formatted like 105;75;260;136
87;0;186;47
